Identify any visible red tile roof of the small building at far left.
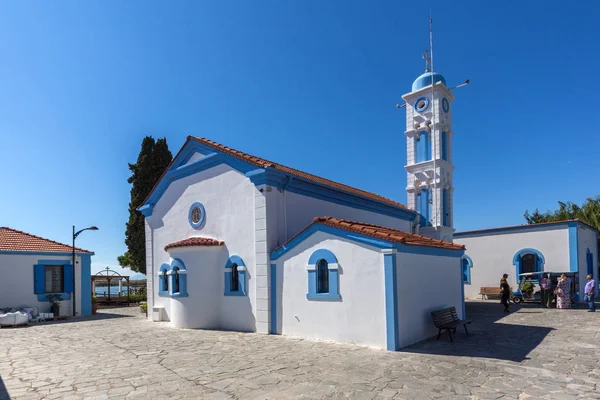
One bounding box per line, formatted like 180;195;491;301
0;227;92;253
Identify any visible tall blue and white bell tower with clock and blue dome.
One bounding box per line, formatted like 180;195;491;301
402;59;455;242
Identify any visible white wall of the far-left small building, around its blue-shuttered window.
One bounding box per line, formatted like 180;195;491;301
0;254;81;315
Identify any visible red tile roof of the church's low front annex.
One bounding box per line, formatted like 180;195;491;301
279;217;465;250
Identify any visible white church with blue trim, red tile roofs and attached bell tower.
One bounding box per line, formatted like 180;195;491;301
139;62;597;350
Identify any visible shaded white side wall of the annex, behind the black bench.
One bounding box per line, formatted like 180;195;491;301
396;253;464;347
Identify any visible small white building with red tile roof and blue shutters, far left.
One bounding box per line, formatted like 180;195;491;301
0;227;94;316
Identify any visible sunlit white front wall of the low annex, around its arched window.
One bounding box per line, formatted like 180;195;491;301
277;232;386;349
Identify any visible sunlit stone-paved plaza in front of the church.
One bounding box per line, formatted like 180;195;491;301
0;302;600;400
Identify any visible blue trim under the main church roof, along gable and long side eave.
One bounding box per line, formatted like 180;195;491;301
138;140;417;221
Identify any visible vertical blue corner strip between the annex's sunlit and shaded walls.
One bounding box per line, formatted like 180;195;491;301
383;254;400;351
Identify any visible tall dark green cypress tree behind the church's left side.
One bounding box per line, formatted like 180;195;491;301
117;136;173;274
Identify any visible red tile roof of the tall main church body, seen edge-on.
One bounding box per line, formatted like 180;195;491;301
142;136;408;210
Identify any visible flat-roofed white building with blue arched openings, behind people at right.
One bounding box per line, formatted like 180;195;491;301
454;221;598;301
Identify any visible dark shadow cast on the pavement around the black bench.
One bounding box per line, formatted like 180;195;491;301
400;302;553;362
